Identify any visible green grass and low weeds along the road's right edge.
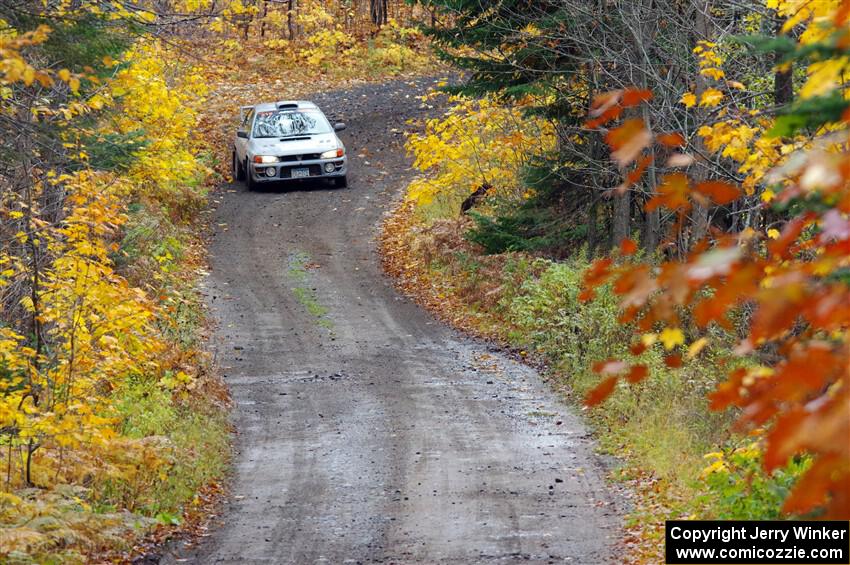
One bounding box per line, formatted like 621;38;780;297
496;258;729;489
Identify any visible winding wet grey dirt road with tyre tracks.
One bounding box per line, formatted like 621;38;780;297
164;80;618;564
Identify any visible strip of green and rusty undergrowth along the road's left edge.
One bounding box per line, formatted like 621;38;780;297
105;197;230;524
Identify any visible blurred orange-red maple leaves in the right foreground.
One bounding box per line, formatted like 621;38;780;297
581;81;850;519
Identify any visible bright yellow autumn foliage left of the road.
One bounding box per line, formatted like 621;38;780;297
0;32;206;498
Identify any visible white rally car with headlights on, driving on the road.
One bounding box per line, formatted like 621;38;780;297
233;100;348;190
